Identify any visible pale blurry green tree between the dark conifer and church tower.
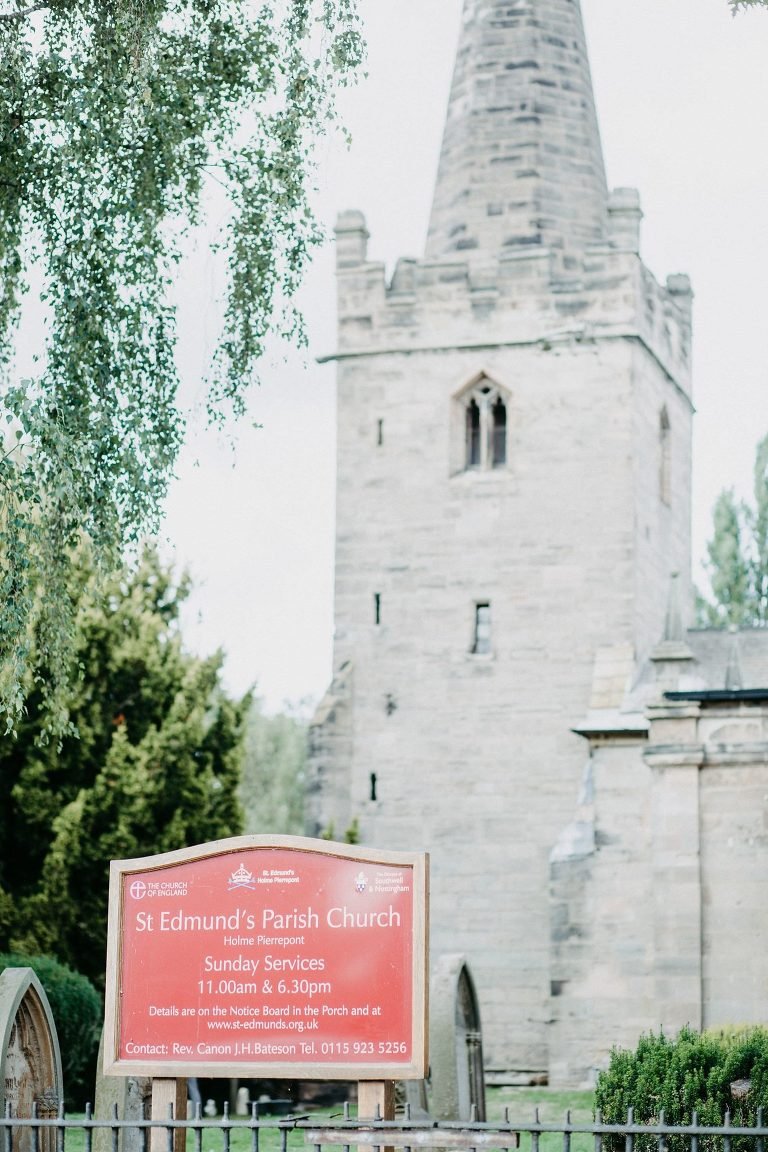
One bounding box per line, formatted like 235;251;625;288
239;699;307;835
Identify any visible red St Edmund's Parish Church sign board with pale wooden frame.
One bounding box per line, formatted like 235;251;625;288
104;836;427;1081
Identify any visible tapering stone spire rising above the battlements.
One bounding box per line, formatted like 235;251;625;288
426;0;607;260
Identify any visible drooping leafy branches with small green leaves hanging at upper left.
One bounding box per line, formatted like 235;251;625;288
0;0;362;733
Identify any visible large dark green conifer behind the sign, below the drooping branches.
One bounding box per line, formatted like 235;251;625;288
0;551;250;983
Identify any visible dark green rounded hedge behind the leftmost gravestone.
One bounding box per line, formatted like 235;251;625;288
0;953;102;1108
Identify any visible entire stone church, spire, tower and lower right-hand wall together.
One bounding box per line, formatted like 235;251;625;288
309;0;768;1083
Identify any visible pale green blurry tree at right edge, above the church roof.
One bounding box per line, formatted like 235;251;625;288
698;437;768;628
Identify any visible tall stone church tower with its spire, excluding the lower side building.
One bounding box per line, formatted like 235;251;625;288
309;0;692;1075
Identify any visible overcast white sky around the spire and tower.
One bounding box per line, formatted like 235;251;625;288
165;0;768;710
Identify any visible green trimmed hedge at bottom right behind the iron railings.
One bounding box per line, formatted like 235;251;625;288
595;1026;768;1149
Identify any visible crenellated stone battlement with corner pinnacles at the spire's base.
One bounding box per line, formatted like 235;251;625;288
329;189;692;393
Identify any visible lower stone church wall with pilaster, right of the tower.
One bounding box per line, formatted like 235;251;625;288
550;686;768;1084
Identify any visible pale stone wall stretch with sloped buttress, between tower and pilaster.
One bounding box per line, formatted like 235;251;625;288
548;735;655;1086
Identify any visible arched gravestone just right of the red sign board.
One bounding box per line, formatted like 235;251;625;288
429;953;486;1120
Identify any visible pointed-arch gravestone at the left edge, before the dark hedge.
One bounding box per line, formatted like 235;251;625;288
0;968;63;1152
